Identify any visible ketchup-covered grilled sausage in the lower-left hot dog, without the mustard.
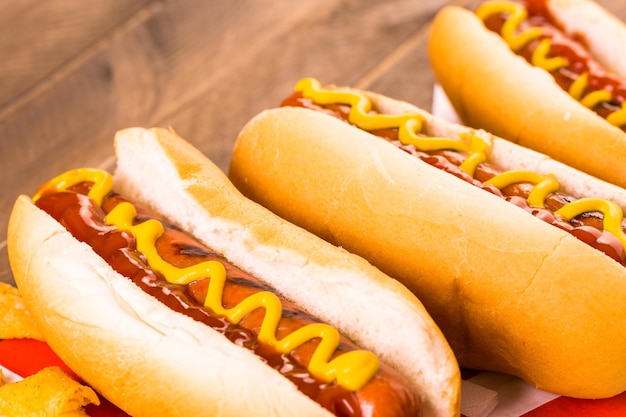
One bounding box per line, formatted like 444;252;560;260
36;183;420;417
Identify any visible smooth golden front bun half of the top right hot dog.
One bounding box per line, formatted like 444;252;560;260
429;6;626;187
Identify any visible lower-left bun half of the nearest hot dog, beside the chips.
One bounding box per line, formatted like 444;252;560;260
10;197;328;416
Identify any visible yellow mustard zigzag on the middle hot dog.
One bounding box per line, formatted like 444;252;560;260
295;78;626;249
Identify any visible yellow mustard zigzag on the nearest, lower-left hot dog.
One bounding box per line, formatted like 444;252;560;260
33;168;380;391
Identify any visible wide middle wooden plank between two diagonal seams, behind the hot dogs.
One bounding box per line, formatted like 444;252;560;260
0;0;444;280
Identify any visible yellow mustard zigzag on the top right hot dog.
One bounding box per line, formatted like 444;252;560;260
476;0;626;127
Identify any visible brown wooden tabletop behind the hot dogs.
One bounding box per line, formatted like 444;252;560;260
0;0;626;282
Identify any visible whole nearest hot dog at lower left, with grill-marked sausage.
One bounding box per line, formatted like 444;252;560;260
8;128;460;416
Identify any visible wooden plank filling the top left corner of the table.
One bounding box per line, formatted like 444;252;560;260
0;0;150;109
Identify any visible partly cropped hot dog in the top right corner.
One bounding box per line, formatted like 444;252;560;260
429;0;626;187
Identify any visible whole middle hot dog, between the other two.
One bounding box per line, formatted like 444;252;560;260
229;79;626;398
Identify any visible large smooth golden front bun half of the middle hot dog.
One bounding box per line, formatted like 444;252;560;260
229;108;626;398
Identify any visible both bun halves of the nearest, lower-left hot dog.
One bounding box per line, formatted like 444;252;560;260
9;128;460;416
